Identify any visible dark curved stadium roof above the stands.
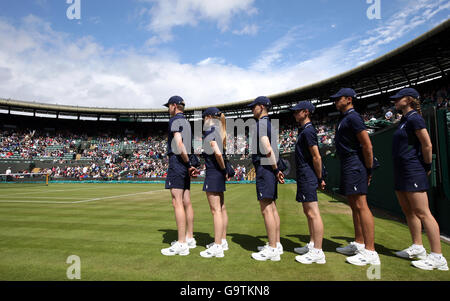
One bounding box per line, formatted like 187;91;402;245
0;19;450;122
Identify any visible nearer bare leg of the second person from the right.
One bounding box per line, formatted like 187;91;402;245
348;194;375;251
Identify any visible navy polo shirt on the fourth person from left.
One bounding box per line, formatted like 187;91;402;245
295;122;319;167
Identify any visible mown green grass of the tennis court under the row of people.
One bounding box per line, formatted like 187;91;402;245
0;180;450;281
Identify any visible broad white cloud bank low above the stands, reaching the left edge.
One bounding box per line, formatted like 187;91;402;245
0;16;345;108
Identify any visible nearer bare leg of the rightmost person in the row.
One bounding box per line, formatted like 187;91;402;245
405;192;442;254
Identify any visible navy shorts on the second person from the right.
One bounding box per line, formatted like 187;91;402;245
340;155;369;196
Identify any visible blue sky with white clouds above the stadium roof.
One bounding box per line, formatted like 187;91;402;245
0;0;450;108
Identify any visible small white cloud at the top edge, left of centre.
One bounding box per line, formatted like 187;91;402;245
141;0;257;43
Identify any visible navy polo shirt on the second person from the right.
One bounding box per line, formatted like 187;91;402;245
334;108;367;158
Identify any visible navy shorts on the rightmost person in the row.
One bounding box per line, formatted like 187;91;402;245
394;162;430;192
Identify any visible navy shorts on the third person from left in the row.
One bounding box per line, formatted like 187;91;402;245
255;165;278;201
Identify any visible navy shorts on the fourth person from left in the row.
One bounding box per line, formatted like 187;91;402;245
295;166;319;203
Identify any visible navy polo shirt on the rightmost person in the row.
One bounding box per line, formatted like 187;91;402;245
392;110;426;164
